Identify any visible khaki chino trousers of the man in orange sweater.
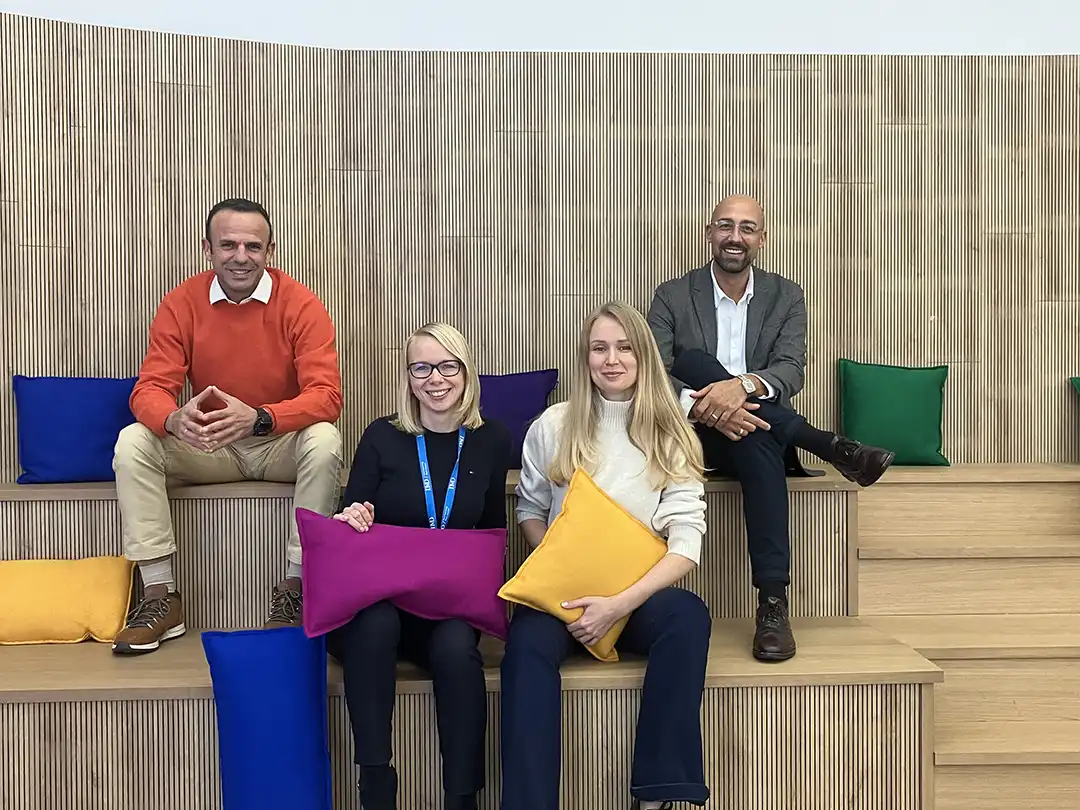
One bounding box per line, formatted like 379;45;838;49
112;422;342;564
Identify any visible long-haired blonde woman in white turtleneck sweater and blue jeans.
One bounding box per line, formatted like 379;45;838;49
501;302;712;810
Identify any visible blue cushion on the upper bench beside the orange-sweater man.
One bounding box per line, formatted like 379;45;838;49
12;375;137;484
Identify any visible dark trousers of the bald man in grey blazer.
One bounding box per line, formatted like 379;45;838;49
672;349;806;589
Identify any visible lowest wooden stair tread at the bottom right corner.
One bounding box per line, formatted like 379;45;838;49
934;720;1080;765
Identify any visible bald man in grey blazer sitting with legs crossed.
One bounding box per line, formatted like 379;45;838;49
648;197;894;661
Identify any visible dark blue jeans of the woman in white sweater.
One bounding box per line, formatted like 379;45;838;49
501;588;712;810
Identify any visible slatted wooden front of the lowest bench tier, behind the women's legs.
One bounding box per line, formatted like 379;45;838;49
0;684;927;810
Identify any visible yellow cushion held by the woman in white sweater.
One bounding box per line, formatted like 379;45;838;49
499;470;667;661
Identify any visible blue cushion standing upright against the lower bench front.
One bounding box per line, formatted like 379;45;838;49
202;627;333;810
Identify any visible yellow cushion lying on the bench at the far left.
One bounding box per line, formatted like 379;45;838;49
0;557;135;644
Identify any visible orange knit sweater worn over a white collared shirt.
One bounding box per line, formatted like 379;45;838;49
131;268;341;436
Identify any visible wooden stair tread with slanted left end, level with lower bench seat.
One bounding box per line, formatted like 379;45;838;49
862;613;1080;661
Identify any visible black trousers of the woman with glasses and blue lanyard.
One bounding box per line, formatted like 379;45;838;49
326;602;487;796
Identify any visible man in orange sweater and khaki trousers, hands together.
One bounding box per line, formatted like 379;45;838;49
112;200;342;653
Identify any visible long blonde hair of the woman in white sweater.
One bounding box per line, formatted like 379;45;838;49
548;301;705;489
